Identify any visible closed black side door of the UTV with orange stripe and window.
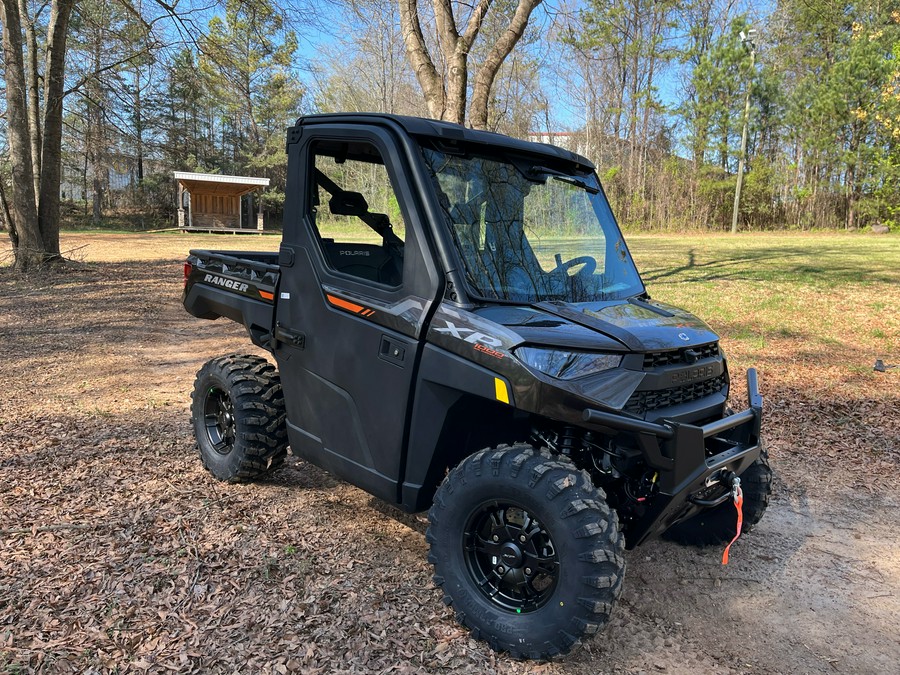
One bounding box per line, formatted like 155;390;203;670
275;125;440;502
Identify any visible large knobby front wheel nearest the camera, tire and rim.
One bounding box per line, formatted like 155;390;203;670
427;444;625;659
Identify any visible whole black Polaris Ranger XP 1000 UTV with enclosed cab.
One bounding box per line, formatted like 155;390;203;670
183;114;771;658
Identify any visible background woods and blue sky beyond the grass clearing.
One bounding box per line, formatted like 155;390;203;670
0;0;900;238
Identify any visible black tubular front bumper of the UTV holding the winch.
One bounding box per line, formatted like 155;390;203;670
583;368;763;548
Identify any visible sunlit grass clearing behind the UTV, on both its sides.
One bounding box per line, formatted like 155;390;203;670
0;228;900;367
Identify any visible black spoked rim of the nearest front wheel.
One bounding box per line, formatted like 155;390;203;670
464;501;559;614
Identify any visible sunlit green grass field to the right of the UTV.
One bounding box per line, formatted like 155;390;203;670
629;234;900;353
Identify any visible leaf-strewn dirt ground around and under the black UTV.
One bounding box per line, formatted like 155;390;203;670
0;237;900;674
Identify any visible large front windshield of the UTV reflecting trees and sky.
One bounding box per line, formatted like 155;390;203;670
425;149;644;303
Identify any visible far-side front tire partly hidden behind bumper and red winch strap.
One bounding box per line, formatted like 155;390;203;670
663;446;772;546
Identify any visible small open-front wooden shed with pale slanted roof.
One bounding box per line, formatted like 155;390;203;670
174;171;269;232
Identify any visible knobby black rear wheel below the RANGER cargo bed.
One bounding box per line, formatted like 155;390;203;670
191;354;287;483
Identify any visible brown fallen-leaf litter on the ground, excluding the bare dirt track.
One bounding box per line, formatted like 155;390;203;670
0;235;900;673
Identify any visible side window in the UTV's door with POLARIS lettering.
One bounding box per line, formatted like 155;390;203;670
309;141;406;287
